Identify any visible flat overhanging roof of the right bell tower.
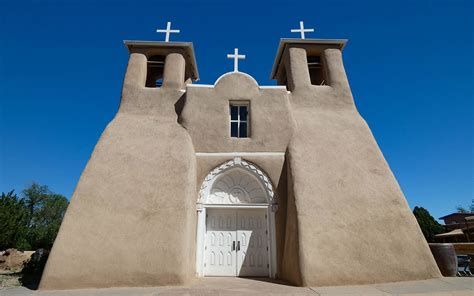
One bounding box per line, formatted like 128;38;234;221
270;38;347;79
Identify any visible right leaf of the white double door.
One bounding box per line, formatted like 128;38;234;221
237;209;269;276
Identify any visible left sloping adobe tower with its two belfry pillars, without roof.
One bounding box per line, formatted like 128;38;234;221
40;53;196;289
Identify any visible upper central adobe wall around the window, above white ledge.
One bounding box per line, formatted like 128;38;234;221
180;72;294;152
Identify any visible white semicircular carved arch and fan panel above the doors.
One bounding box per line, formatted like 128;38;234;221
197;157;278;210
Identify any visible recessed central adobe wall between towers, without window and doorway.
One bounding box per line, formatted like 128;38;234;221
180;72;295;280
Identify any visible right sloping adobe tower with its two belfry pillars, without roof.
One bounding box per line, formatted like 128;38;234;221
282;47;441;286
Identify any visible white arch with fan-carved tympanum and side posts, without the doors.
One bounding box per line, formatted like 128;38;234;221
196;157;278;277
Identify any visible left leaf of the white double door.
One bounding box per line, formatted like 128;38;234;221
204;209;237;276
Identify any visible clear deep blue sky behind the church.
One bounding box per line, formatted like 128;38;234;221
0;0;474;221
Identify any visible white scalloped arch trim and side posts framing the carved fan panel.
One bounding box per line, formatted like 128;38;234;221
196;157;278;278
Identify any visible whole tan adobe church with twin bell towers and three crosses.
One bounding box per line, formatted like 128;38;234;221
40;23;441;289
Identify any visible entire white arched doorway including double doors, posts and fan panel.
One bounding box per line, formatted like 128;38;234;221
196;157;277;277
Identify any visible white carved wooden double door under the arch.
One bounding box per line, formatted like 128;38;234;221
204;209;269;277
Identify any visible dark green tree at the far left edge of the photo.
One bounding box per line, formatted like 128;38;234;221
0;190;30;250
